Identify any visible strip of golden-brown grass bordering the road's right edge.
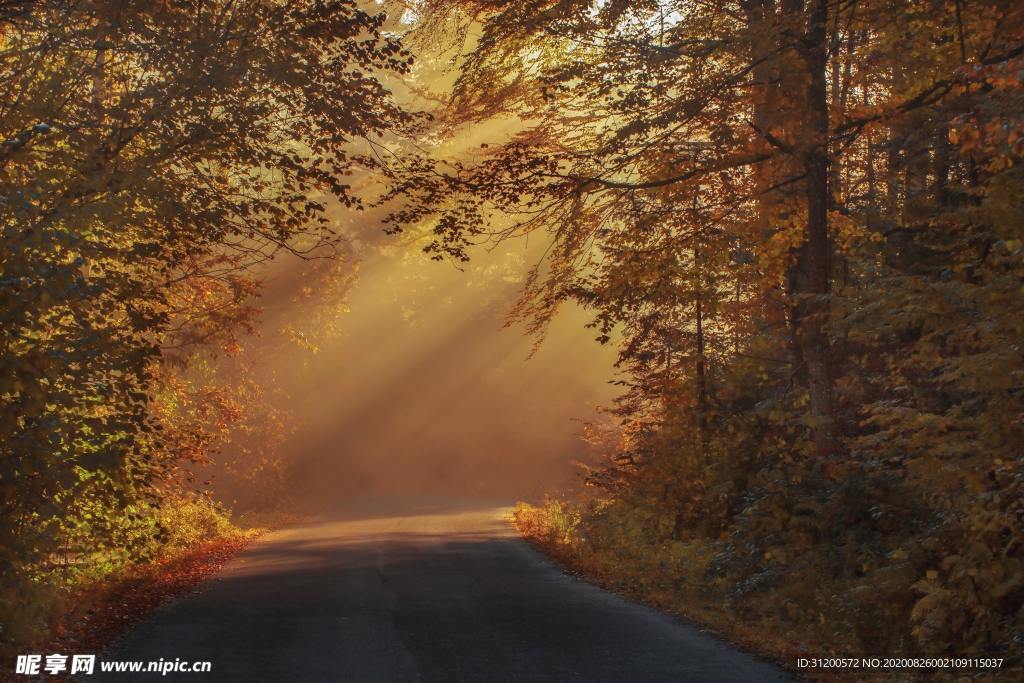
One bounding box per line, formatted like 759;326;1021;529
512;499;1022;683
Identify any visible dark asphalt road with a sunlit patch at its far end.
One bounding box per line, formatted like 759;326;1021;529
96;498;792;683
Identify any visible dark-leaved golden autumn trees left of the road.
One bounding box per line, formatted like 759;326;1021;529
0;0;413;639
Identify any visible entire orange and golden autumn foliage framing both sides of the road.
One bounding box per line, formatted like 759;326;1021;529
0;0;1024;670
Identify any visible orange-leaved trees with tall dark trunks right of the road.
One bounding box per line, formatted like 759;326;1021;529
393;0;1024;651
